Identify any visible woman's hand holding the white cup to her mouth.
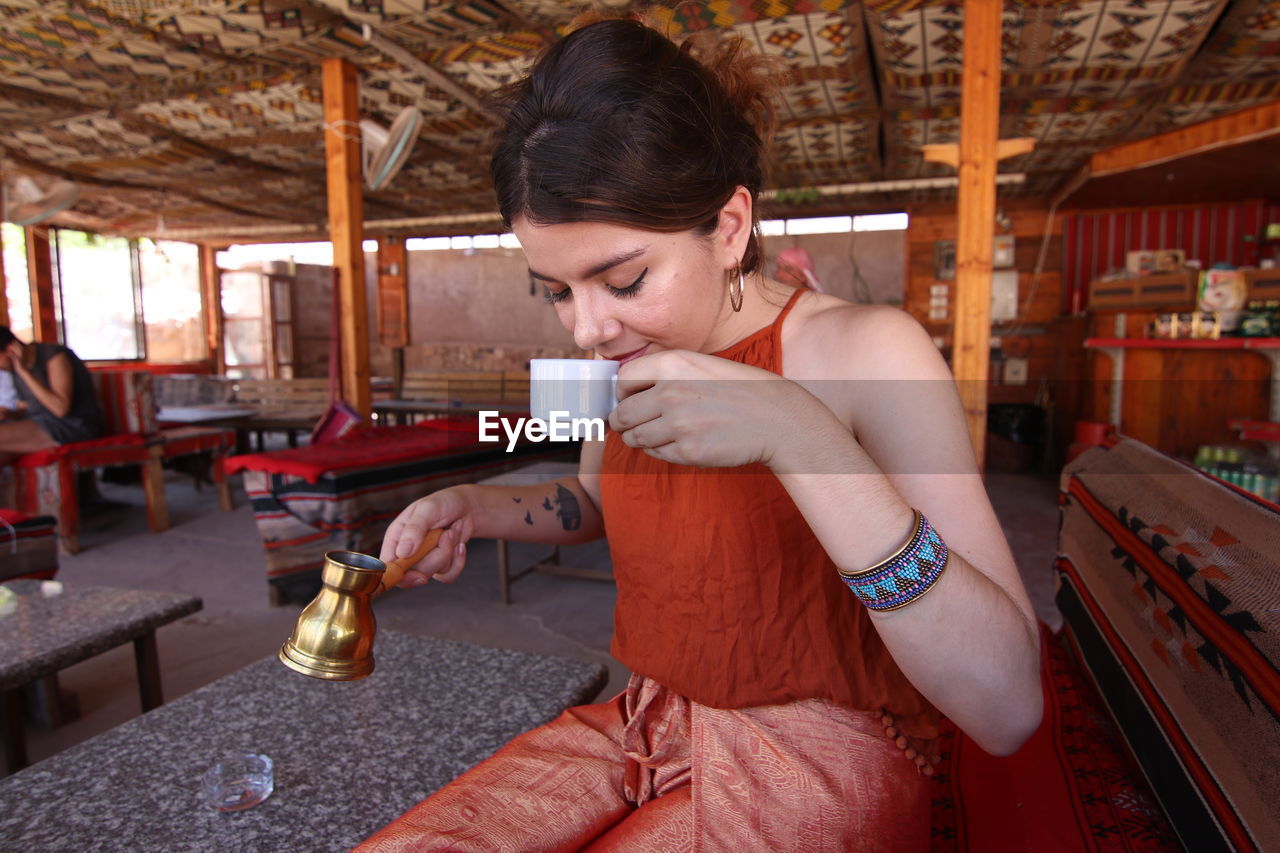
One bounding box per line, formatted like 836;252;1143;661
609;350;829;467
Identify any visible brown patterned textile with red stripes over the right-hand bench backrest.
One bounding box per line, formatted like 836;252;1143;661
1057;438;1280;853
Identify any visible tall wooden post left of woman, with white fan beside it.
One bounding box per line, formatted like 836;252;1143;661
321;59;372;418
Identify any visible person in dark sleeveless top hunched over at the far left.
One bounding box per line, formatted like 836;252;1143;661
0;325;102;465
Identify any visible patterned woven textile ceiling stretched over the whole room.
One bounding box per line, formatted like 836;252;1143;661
0;0;1280;240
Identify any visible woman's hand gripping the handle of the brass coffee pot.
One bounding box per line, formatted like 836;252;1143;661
379;487;475;587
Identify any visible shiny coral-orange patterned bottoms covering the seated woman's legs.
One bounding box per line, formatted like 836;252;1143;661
357;675;929;853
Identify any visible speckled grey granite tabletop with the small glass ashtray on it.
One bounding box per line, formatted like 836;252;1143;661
0;630;607;853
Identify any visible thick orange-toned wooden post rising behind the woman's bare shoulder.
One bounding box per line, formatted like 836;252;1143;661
951;0;1001;471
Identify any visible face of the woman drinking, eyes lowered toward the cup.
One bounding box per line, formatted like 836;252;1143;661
512;218;732;361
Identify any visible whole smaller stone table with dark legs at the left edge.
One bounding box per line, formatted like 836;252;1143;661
0;580;204;771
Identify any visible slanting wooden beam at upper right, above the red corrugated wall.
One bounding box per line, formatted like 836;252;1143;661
1088;101;1280;178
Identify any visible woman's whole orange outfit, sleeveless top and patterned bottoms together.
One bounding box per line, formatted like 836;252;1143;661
358;289;937;853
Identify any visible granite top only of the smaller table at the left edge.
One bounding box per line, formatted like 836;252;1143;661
0;580;204;689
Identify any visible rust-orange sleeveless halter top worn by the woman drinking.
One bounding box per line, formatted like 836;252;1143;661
600;285;938;739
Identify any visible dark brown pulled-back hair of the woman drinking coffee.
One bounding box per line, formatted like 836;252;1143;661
490;19;777;273
